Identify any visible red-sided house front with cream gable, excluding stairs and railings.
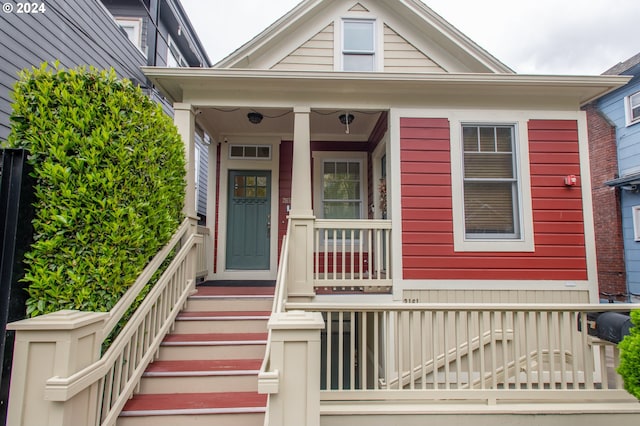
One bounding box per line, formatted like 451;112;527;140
145;1;623;302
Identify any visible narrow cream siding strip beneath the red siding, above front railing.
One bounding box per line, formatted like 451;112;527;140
403;290;589;303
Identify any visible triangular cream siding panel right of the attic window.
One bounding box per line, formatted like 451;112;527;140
384;25;446;73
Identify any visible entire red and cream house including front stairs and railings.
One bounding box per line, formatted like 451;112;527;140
10;0;640;426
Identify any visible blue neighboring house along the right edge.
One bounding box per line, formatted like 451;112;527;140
589;53;640;303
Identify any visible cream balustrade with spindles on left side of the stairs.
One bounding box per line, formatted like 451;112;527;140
44;219;202;425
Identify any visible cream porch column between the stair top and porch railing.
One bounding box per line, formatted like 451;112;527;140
288;107;315;299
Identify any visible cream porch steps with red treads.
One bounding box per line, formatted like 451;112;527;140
117;287;273;426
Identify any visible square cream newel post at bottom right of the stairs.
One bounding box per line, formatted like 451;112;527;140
260;311;324;426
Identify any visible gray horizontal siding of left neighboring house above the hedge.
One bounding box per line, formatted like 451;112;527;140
0;0;146;140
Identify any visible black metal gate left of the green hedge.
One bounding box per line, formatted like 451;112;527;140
0;149;34;424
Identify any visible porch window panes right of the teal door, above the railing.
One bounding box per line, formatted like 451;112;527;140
322;160;364;219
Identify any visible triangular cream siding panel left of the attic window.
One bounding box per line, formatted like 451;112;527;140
272;24;334;71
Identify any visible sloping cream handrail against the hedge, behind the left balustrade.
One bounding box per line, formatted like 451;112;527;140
102;218;195;338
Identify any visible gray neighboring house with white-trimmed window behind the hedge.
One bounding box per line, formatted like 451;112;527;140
0;0;211;220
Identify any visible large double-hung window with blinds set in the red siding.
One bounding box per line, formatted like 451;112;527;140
462;124;521;240
